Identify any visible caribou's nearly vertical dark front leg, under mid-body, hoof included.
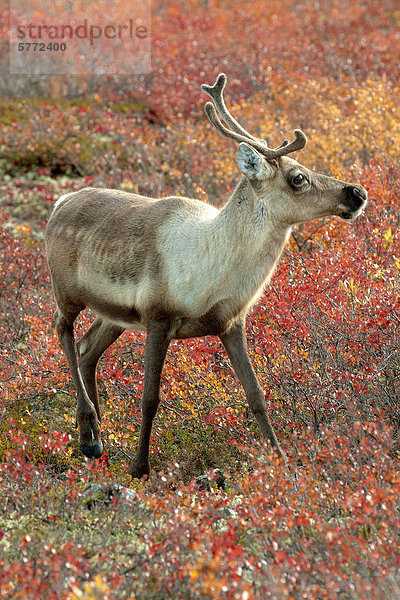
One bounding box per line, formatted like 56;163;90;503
128;321;171;479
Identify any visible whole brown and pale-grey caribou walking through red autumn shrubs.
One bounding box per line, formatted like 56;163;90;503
45;73;367;478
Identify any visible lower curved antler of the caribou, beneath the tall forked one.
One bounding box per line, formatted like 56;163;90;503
204;102;307;160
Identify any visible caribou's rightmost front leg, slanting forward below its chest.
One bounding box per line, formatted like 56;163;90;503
220;321;287;464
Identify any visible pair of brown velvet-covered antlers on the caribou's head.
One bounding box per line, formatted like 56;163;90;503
201;73;307;160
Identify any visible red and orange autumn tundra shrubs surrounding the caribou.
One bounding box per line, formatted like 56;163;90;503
0;0;400;600
